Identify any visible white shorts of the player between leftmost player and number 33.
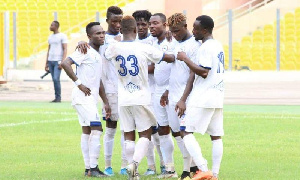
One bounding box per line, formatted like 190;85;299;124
102;93;119;121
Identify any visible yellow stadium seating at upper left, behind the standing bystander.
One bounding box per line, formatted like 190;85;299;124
0;0;133;63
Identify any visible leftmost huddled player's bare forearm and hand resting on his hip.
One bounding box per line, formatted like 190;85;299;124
61;58;91;96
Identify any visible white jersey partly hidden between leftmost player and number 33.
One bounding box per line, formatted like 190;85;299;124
100;33;122;93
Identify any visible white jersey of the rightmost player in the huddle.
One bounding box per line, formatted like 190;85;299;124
188;39;225;108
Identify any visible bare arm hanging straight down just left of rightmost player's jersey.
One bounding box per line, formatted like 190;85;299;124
175;71;195;117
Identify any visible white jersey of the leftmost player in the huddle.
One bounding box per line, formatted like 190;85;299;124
69;47;102;105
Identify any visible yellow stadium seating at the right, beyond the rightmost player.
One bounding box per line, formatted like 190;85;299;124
224;7;300;70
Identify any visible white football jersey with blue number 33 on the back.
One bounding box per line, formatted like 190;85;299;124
105;41;164;106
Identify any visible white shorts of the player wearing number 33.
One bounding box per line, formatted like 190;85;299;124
119;106;157;132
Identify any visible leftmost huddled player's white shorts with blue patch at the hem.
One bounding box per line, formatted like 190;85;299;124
73;104;101;126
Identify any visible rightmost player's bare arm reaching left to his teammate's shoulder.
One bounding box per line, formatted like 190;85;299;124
177;52;209;79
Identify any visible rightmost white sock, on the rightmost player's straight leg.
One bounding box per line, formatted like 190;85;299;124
212;139;223;176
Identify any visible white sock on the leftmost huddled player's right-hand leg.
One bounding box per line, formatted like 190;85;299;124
89;130;102;168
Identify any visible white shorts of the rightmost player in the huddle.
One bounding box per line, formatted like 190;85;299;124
180;107;224;136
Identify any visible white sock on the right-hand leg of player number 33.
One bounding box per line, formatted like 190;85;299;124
133;137;150;163
